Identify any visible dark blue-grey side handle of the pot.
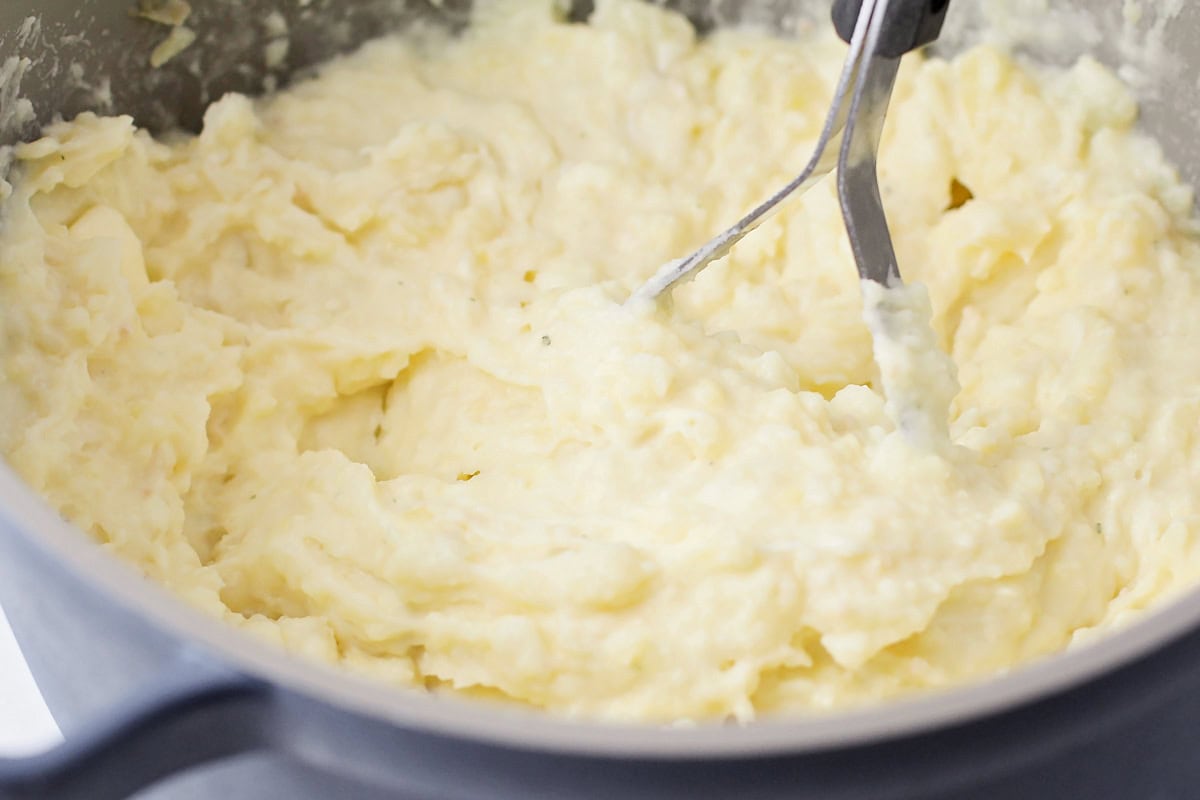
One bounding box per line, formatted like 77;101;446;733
0;652;276;800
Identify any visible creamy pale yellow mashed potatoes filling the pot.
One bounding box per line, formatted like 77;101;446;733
0;0;1200;721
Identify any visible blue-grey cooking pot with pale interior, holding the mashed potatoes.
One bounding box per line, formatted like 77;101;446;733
0;0;1200;800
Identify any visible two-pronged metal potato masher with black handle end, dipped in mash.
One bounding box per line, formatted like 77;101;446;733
630;0;949;302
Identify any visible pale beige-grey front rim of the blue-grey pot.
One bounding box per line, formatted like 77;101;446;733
0;459;1200;759
